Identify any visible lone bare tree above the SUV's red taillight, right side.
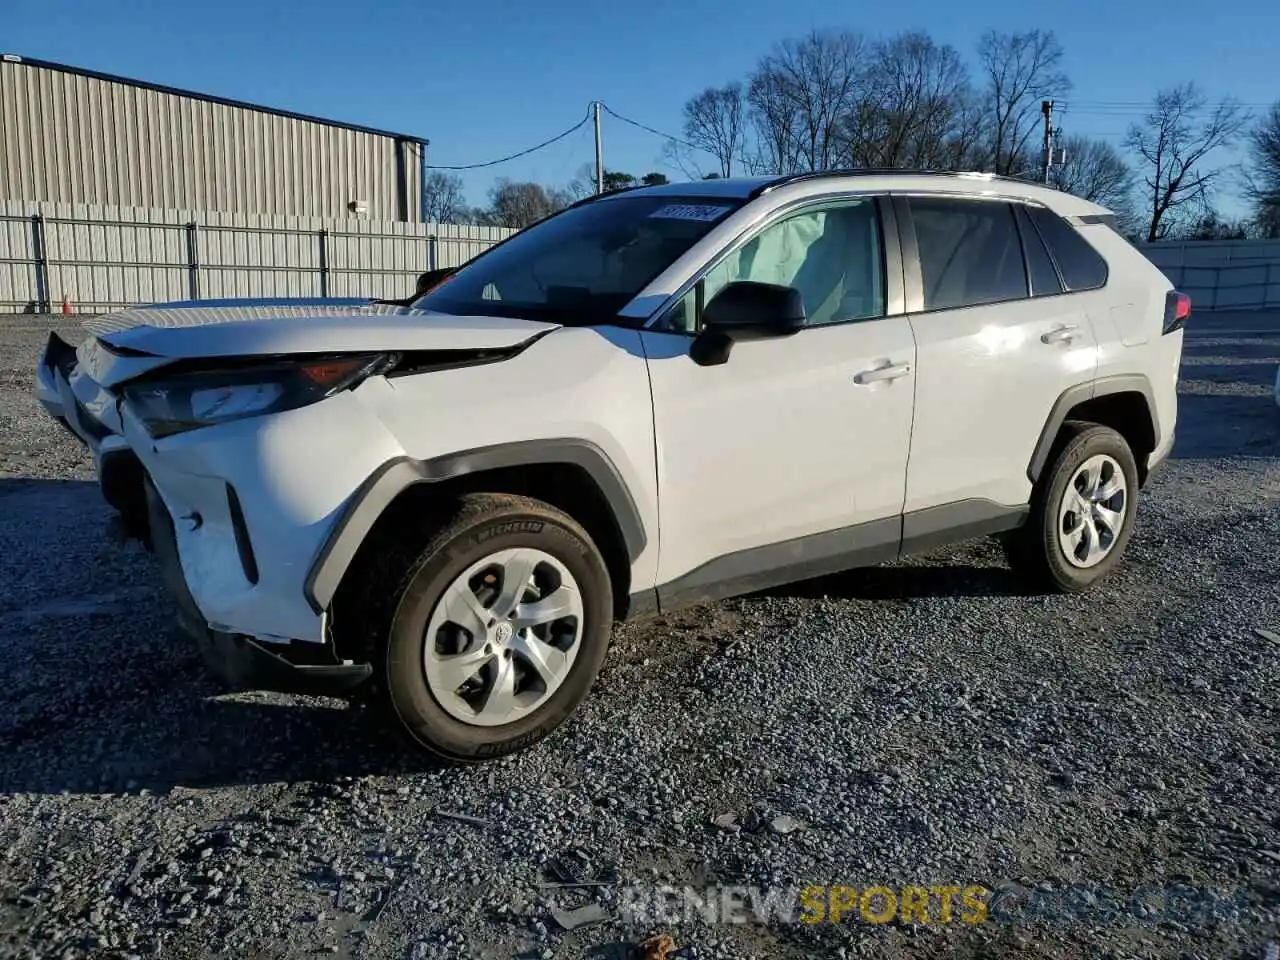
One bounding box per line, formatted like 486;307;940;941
1125;83;1249;243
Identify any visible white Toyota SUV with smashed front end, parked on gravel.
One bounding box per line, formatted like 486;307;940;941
37;172;1190;760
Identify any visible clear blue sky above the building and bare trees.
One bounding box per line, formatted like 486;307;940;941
0;0;1280;209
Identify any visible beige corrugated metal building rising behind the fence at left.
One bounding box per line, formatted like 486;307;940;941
0;54;428;223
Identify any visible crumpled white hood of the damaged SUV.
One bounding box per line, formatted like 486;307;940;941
84;300;558;360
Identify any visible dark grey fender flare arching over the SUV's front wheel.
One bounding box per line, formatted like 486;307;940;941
303;438;648;613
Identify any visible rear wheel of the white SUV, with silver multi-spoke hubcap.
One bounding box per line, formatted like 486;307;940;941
1005;422;1138;593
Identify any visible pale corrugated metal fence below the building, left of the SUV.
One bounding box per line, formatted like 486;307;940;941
0;200;515;312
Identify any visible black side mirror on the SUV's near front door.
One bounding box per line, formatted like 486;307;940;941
689;280;805;366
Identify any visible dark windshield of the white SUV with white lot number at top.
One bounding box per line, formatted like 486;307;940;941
413;195;742;325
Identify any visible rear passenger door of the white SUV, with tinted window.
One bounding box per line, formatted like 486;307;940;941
895;196;1097;519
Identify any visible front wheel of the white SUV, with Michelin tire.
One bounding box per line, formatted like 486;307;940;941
380;494;613;762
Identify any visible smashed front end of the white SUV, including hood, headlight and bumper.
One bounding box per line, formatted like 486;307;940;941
36;306;556;694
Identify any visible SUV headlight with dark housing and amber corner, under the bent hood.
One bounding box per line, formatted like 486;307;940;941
123;353;393;438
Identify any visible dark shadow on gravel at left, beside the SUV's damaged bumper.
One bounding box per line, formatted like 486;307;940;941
0;477;450;796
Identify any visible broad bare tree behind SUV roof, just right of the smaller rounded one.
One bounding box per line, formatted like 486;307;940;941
746;31;867;173
